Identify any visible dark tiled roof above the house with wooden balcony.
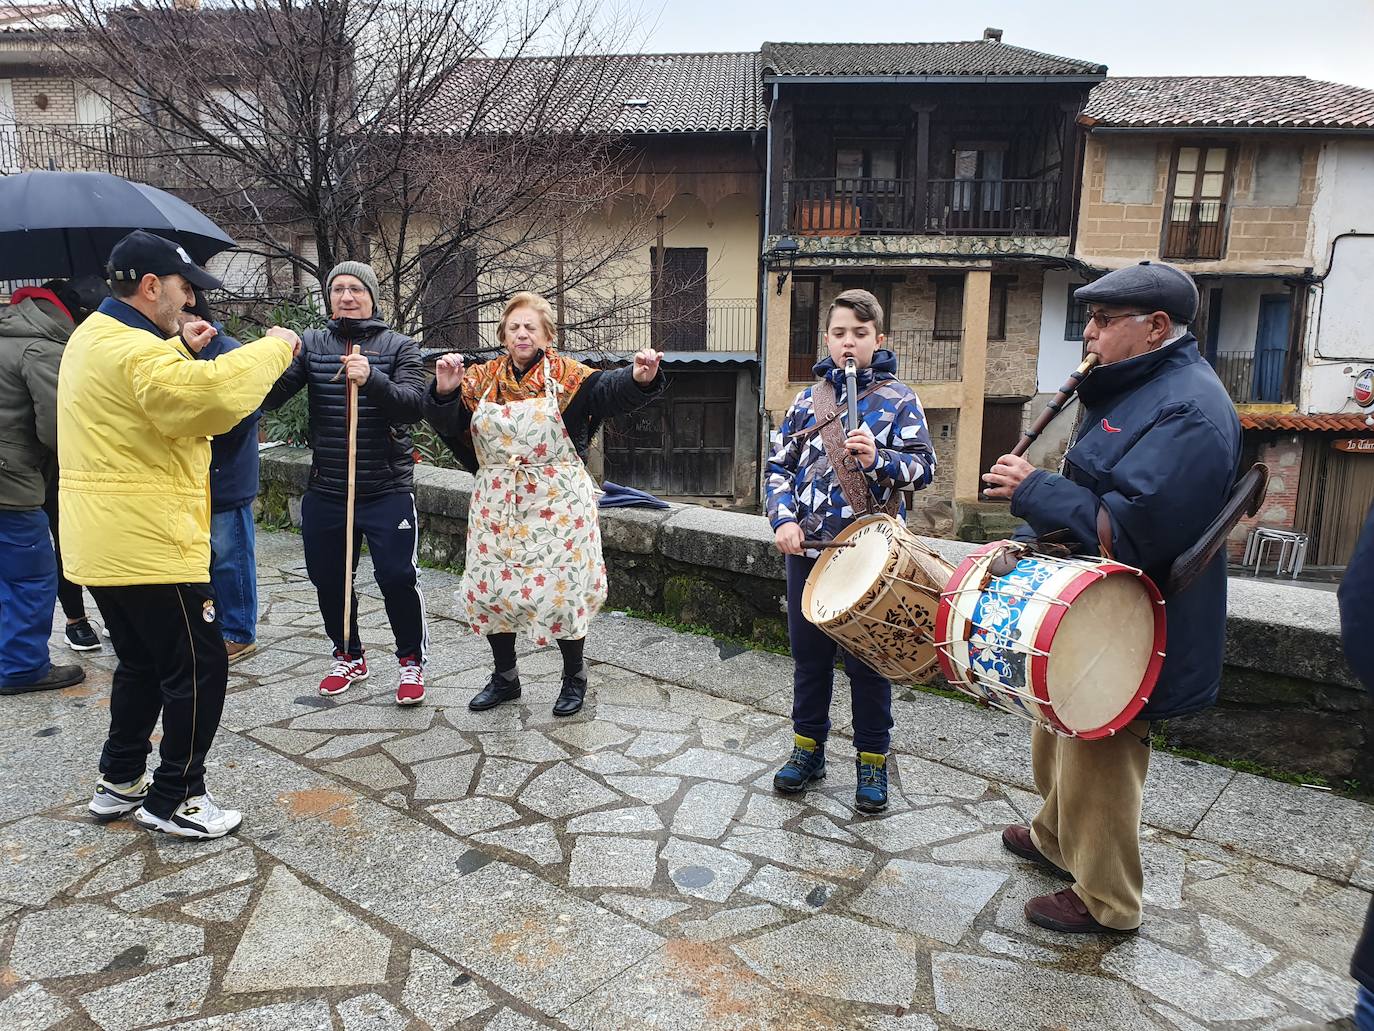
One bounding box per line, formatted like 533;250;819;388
763;40;1107;78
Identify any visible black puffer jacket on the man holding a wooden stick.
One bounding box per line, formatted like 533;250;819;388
262;319;425;498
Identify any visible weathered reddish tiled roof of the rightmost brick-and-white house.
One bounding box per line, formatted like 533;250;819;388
1083;76;1374;129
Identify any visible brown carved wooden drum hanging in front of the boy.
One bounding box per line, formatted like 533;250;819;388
801;516;954;682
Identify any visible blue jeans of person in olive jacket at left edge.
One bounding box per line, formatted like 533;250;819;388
0;509;58;685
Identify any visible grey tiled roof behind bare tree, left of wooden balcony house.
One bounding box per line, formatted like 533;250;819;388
420;52;768;135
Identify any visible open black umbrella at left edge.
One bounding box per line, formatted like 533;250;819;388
0;172;234;279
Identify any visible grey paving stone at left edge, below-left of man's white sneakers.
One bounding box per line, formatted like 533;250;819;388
0;817;137;906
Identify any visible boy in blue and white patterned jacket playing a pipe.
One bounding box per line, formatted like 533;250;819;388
768;290;936;812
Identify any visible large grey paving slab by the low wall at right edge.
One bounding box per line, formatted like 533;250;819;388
1197;774;1374;880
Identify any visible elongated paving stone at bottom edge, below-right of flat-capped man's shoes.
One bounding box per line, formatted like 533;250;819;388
1102;938;1285;1020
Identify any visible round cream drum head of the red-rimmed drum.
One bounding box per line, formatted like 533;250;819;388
1047;573;1154;734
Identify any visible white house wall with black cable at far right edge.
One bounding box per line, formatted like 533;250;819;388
1298;140;1374;414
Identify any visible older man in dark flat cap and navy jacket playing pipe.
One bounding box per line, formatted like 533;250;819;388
982;261;1241;933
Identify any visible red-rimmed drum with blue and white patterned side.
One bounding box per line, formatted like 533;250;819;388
936;540;1165;738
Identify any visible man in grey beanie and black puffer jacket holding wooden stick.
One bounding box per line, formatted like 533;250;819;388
264;261;429;705
